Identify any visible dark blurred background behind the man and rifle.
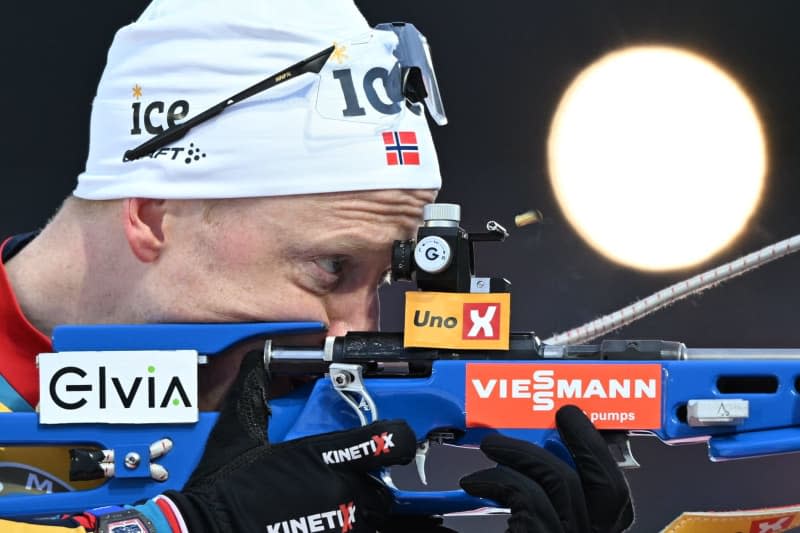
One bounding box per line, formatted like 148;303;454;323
0;0;800;532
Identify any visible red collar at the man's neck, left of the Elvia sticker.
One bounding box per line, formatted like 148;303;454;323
0;235;53;406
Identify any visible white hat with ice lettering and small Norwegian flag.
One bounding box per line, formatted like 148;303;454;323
74;0;441;200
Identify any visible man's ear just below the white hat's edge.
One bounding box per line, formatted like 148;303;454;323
122;198;166;263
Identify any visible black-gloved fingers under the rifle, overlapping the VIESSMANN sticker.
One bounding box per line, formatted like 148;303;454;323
461;405;633;533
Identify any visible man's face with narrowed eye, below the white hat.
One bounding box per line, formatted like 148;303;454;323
150;190;435;404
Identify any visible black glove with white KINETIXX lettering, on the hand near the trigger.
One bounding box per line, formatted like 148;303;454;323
165;352;416;533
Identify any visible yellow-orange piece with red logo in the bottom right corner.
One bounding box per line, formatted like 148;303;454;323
661;504;800;533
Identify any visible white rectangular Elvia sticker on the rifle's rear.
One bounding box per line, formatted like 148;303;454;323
37;350;198;424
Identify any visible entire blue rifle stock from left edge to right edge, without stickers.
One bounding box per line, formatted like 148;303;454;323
0;323;800;516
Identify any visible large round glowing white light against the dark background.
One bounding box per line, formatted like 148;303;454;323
548;46;767;270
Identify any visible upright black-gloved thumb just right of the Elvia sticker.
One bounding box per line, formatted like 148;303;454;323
187;351;269;486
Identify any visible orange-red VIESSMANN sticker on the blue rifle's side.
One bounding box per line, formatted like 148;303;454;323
465;362;661;429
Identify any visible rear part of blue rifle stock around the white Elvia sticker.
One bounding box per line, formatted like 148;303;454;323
0;322;324;517
